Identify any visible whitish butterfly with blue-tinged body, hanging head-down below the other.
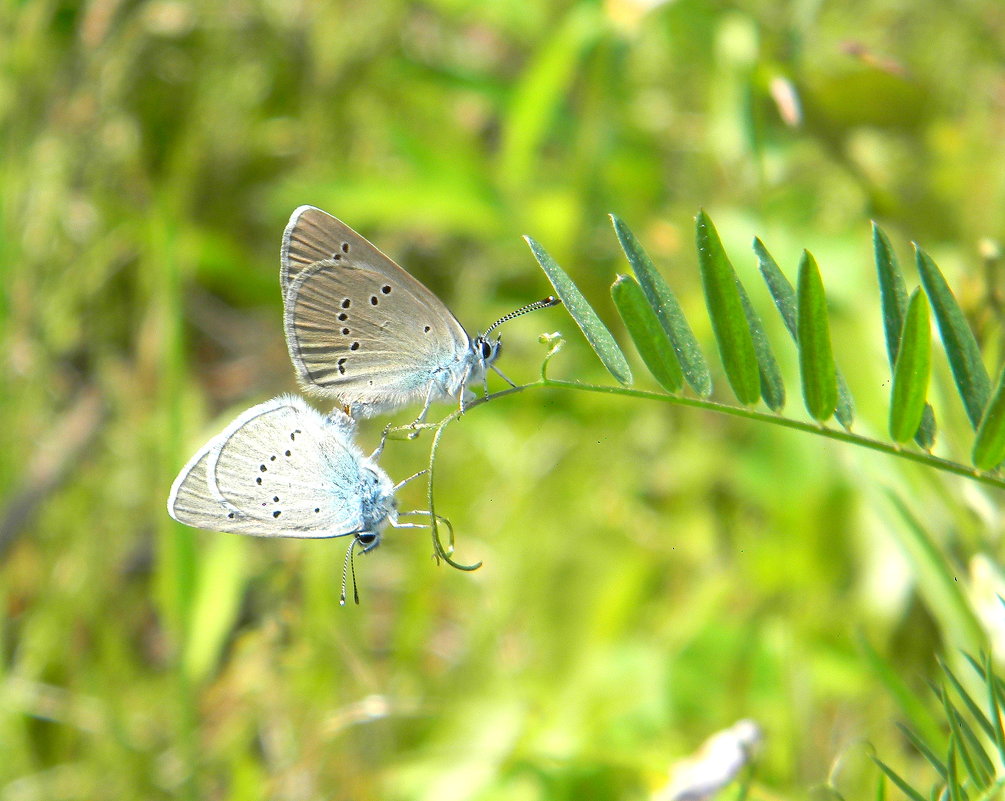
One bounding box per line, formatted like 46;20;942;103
168;395;428;603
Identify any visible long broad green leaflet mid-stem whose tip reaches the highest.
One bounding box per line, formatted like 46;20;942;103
694;210;759;404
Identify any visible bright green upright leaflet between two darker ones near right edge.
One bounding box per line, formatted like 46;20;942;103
889;289;932;442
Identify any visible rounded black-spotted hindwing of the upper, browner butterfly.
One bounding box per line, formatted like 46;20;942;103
283;256;471;413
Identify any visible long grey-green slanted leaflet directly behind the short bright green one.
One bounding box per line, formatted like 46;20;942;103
611;214;712;398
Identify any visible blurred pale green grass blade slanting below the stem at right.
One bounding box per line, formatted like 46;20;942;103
885;490;984;652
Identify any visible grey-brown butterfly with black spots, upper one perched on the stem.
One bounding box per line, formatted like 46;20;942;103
279;206;559;420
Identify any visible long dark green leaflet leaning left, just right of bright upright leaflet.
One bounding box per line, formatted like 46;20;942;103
915;244;991;428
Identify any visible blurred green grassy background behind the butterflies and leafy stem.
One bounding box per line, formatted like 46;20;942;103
0;0;1005;801
